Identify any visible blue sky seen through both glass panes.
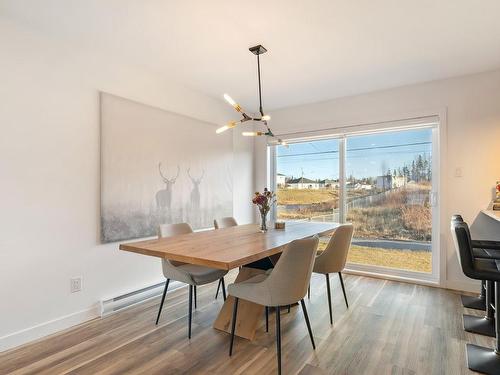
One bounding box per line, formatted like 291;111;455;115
276;129;432;180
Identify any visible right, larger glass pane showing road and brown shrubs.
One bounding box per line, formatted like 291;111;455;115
346;129;432;273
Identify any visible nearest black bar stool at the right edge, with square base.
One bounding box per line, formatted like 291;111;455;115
451;220;500;375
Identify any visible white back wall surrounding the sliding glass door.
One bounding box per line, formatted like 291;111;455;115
254;70;500;290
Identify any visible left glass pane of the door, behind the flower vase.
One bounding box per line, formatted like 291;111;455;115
276;139;339;229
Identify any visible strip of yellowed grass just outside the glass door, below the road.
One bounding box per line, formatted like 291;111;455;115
318;242;432;273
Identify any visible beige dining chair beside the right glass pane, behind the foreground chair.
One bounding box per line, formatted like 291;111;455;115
308;224;354;324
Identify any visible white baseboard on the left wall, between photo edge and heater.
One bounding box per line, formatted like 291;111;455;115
0;303;100;352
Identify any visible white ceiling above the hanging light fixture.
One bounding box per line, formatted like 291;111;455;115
0;0;500;110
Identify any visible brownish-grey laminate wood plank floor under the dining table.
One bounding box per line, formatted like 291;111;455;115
0;272;493;375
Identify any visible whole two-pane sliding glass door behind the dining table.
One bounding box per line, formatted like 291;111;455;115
274;127;436;278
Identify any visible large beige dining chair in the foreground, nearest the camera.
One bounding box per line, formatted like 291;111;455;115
228;236;319;374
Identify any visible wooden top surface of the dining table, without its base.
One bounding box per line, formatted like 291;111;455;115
120;221;340;270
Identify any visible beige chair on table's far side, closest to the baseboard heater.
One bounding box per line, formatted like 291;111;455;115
156;223;227;338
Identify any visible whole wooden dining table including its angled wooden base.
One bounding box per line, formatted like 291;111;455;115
120;222;339;340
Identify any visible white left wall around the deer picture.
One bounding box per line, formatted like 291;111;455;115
0;18;253;350
